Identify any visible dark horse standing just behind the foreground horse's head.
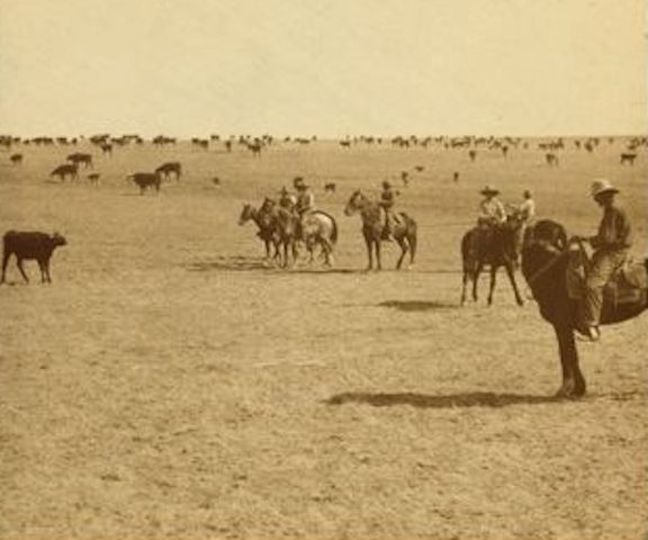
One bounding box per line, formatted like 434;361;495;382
461;215;524;306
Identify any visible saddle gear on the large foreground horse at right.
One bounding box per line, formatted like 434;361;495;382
566;251;648;310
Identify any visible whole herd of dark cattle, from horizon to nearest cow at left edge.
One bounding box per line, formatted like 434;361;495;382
0;134;648;283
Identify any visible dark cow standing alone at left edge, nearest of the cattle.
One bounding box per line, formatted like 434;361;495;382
0;231;67;283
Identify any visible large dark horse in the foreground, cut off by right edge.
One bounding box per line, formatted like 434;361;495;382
522;220;648;398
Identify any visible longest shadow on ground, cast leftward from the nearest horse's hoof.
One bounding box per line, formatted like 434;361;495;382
324;392;561;409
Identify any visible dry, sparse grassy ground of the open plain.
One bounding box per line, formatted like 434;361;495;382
0;140;648;540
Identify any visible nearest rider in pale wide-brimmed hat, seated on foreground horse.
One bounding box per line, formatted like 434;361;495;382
577;178;632;341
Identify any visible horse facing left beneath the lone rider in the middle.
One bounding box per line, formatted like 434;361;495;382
344;190;417;270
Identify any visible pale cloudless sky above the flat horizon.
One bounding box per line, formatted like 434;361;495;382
0;0;648;137
